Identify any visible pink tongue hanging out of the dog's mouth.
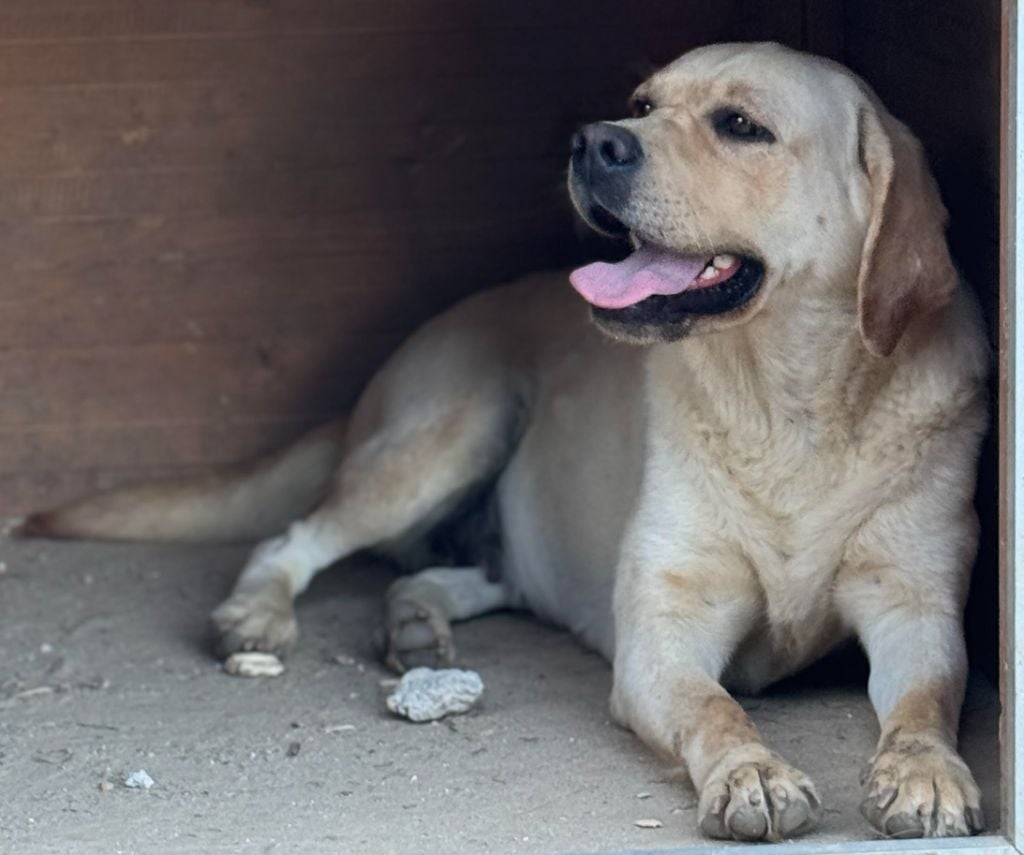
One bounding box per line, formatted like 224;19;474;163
569;244;708;309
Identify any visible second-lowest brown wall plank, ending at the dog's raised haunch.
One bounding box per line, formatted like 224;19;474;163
0;334;398;431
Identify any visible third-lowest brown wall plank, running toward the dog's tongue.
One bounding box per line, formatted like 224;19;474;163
0;240;573;354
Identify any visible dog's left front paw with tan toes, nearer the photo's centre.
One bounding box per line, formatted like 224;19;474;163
697;745;821;841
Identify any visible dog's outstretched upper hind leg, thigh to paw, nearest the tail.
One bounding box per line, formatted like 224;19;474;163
212;394;515;653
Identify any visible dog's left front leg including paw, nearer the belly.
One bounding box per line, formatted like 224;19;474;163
612;550;820;841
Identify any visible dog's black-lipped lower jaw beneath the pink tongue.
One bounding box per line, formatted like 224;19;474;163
593;256;765;327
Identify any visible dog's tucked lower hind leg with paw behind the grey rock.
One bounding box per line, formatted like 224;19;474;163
385;567;513;672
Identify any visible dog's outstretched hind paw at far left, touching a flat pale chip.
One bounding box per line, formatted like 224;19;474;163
210;582;299;656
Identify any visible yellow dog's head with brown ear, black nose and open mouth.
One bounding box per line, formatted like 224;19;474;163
569;44;956;355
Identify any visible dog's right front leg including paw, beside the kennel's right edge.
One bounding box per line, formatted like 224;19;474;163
836;495;984;838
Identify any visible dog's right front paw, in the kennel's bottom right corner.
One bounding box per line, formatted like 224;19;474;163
860;736;985;838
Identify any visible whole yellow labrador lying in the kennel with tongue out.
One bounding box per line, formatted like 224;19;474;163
25;44;987;841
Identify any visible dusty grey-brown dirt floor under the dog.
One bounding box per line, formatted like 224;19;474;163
0;542;998;855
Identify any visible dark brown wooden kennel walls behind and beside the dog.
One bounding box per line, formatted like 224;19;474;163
0;0;1011;851
